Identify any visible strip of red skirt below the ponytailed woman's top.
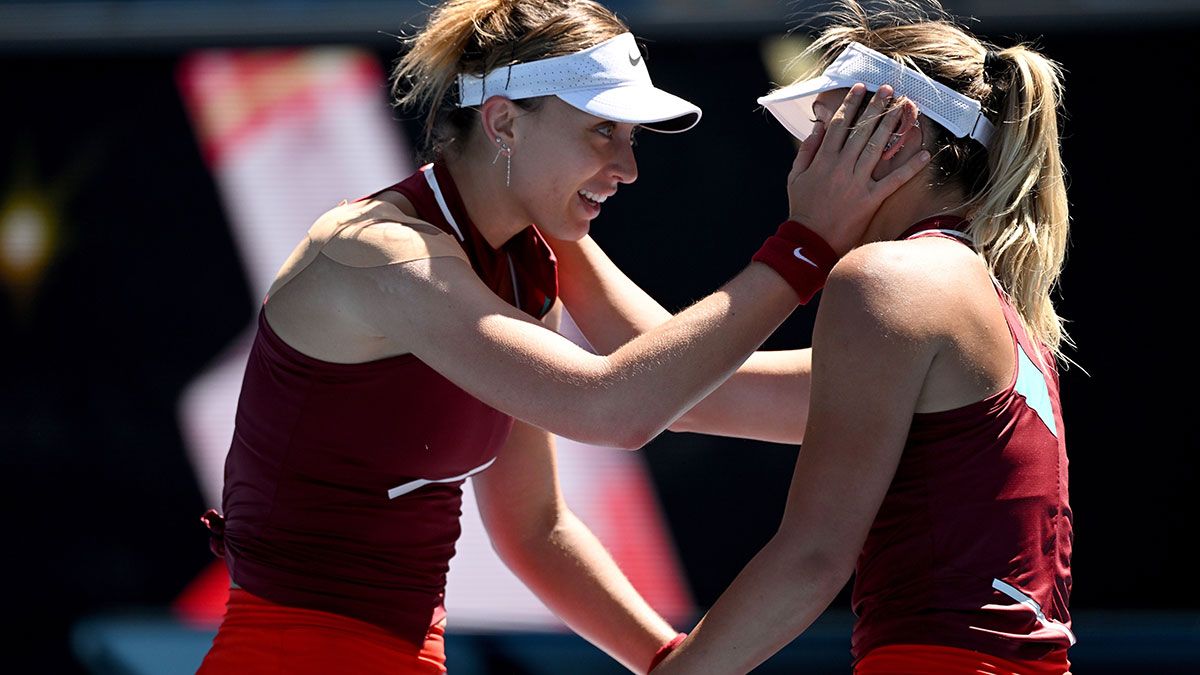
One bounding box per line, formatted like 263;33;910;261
854;645;1070;675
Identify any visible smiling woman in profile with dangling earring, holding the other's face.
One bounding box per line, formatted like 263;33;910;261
200;0;928;674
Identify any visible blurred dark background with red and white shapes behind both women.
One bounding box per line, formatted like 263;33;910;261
0;0;1200;675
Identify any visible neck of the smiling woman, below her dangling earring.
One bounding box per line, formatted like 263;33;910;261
442;148;529;249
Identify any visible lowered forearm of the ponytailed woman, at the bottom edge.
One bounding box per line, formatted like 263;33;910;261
654;536;850;675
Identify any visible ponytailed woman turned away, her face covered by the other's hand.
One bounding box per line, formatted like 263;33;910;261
556;1;1075;675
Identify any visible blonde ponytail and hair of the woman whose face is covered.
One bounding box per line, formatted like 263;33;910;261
805;0;1072;358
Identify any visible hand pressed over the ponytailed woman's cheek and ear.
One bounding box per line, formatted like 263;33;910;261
787;84;929;255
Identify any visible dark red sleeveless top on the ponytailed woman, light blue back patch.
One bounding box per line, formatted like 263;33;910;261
852;219;1075;661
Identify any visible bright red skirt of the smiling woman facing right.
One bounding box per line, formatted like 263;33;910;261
197;589;446;675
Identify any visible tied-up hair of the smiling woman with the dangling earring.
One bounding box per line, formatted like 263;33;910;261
391;0;629;157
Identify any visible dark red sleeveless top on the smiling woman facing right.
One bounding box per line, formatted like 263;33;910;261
212;166;557;644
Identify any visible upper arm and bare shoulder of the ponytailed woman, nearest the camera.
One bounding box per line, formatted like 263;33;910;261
780;241;941;566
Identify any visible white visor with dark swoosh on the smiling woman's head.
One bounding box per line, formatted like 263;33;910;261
458;32;701;133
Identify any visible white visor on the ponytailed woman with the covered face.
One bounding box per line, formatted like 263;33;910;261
758;42;995;148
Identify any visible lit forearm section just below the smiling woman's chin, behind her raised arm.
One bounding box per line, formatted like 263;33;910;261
551;237;671;354
